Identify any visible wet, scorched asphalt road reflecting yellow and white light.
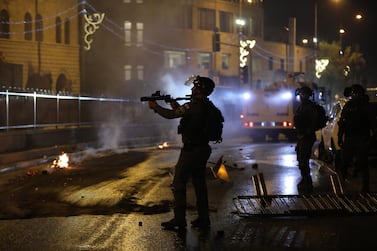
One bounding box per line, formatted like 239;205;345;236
0;139;377;250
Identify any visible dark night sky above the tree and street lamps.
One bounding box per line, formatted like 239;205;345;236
263;0;377;82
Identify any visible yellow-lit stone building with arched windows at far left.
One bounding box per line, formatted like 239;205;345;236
0;0;80;93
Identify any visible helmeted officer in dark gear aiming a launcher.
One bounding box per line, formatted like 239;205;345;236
149;76;215;230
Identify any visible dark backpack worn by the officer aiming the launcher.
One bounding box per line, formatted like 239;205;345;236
205;101;224;143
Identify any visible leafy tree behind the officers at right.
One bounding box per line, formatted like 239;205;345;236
318;42;366;101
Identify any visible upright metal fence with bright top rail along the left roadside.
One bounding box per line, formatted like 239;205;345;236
0;89;147;130
